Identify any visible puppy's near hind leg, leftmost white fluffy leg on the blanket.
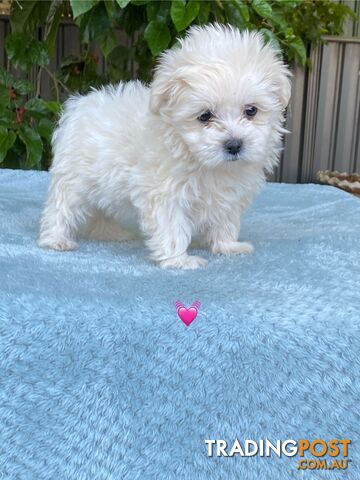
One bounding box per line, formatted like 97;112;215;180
38;177;88;251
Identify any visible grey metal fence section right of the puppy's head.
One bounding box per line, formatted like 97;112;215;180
292;37;360;182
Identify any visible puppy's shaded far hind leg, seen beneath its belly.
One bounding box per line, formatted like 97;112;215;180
86;211;135;242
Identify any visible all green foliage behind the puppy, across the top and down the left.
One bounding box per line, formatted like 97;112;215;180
0;0;356;169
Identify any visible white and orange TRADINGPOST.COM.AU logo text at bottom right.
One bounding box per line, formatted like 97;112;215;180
205;438;351;470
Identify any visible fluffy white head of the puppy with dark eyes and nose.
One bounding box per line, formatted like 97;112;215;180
150;25;290;168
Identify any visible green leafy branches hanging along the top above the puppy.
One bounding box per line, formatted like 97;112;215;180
7;0;355;84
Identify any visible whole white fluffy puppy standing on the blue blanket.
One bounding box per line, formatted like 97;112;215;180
39;25;290;269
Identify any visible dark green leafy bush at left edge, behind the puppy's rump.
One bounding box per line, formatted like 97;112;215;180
0;69;60;169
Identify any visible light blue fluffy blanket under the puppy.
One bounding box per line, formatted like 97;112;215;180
0;171;360;480
